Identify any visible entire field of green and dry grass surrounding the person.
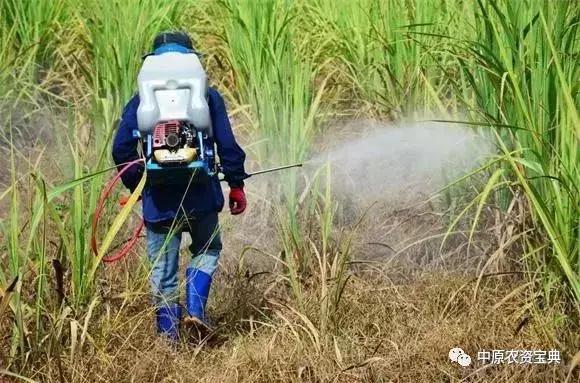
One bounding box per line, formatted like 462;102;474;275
0;0;580;382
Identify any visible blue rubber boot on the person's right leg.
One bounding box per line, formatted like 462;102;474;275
185;267;212;328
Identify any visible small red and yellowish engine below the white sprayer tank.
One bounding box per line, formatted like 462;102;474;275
153;120;199;164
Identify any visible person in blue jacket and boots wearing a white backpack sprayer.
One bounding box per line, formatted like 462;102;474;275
112;31;249;340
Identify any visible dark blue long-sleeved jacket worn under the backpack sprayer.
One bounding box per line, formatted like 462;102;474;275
113;88;246;224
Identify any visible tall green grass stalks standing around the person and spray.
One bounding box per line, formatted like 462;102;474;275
0;0;580;374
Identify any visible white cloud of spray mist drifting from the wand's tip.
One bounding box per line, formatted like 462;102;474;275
309;120;493;208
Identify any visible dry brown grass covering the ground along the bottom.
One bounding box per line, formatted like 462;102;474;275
18;273;568;382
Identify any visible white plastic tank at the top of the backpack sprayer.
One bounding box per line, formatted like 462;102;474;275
137;52;212;136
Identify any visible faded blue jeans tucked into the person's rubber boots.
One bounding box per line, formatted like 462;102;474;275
147;212;222;305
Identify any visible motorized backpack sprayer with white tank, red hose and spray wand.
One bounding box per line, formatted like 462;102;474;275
91;47;302;262
